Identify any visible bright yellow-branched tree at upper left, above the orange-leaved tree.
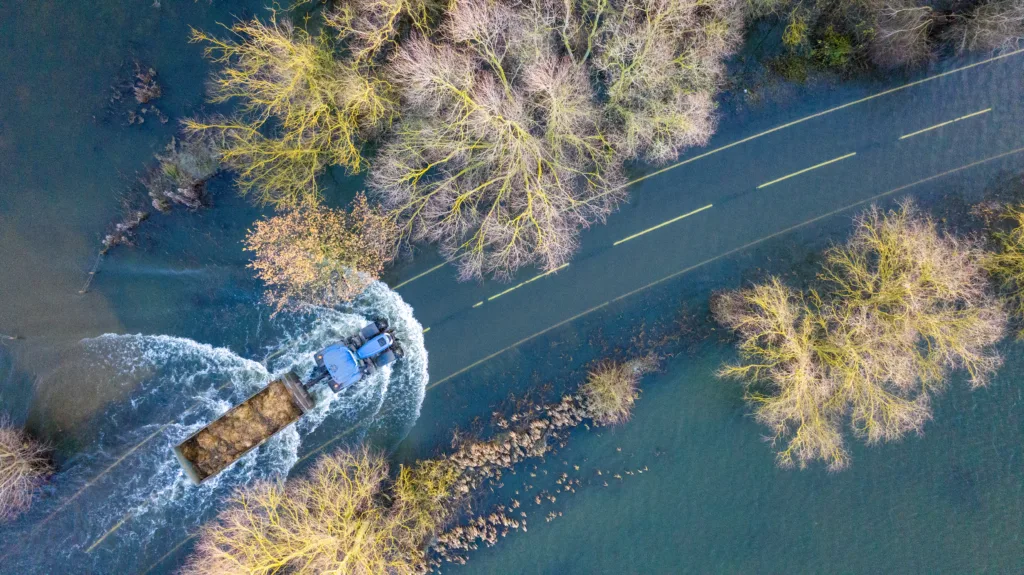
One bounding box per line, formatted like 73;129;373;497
185;19;396;208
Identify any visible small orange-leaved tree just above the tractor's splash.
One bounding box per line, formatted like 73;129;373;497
245;194;397;311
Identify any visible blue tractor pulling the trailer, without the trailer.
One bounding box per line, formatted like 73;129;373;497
305;319;402;393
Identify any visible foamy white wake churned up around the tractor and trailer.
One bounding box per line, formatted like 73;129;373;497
41;282;427;555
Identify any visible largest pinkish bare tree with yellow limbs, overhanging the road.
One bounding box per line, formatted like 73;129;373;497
371;0;624;279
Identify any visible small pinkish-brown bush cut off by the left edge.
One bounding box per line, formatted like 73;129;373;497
0;417;52;522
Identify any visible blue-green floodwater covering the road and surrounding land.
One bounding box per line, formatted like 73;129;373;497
0;0;1024;575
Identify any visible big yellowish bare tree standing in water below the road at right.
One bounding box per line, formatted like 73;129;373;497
713;203;1007;471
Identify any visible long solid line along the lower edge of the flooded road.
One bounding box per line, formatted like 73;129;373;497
427;147;1024;391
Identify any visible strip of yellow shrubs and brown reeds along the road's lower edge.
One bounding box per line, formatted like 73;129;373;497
183;347;657;574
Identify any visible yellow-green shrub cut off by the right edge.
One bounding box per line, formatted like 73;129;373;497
982;205;1024;338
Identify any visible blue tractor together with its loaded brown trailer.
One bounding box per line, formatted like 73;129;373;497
174;320;402;485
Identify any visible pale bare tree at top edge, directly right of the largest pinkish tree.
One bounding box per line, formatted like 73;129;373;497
594;0;742;163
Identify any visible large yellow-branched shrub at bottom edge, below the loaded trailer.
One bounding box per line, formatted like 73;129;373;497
182;449;436;575
